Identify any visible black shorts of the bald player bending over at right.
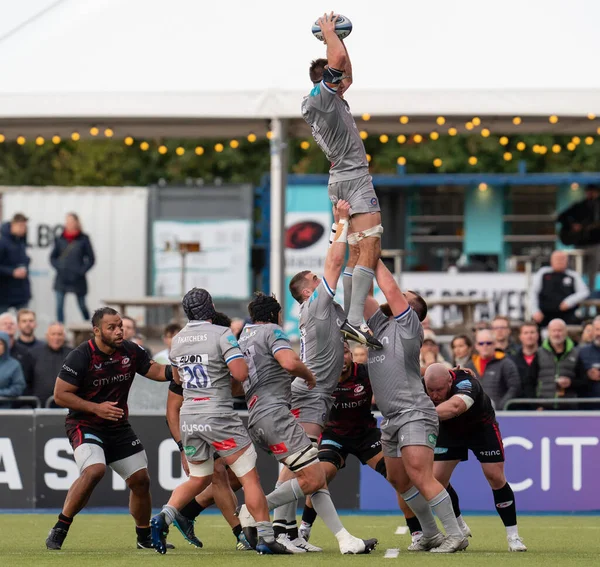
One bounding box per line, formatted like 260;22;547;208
434;421;504;463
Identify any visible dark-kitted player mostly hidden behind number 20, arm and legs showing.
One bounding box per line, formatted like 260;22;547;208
162;311;252;551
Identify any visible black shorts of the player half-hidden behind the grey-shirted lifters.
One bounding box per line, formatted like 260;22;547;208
319;427;381;470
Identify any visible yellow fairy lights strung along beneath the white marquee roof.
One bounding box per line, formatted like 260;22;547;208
0;113;600;168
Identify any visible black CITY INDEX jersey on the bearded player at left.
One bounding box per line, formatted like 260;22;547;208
58;339;153;428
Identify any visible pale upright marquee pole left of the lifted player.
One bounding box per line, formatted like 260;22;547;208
269;118;288;313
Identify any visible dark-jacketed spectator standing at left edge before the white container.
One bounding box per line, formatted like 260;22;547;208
0;213;31;313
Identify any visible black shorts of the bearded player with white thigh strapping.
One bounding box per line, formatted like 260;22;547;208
66;423;144;465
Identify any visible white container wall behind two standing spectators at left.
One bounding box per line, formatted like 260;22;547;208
0;186;148;332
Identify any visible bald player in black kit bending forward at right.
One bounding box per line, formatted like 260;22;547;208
425;364;527;551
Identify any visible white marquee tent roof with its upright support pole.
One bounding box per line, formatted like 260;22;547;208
0;0;600;302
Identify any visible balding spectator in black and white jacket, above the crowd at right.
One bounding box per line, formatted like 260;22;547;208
530;250;590;327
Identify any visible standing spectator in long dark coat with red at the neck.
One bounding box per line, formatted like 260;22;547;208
50;213;95;323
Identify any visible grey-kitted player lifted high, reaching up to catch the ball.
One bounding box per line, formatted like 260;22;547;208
302;12;383;349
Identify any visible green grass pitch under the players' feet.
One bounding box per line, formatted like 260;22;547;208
0;514;600;567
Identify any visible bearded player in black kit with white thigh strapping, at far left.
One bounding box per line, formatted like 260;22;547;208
46;307;173;550
